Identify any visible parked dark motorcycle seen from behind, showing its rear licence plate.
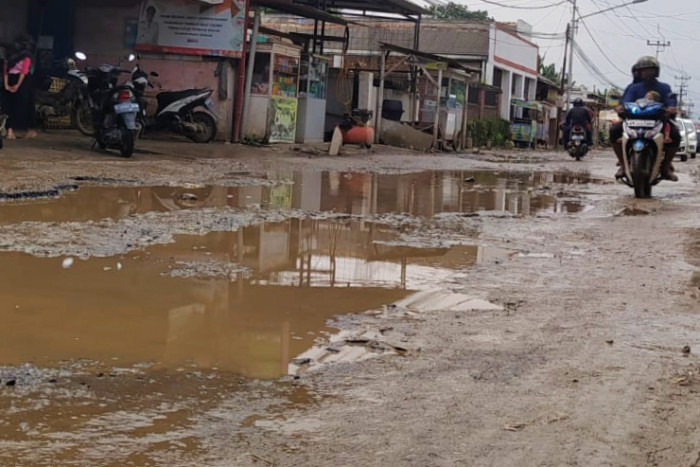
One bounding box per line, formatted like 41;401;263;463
80;57;140;157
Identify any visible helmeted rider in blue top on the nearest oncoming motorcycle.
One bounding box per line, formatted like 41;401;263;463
610;56;681;182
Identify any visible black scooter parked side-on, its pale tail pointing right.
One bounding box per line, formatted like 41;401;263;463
131;64;220;143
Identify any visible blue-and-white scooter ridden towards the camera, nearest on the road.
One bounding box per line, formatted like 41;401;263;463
620;99;665;198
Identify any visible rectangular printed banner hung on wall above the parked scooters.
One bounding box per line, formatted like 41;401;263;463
136;0;245;58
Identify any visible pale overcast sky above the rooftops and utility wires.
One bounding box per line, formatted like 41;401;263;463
417;0;700;116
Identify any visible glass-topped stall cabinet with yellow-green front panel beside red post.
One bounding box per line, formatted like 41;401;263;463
246;42;301;143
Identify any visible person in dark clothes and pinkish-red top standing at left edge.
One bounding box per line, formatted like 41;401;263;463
3;34;36;139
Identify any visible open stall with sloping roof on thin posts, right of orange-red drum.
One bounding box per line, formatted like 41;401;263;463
376;44;478;150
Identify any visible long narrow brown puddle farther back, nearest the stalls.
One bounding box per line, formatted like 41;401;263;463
0;171;597;224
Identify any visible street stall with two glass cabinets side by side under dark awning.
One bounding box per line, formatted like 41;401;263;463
241;0;347;143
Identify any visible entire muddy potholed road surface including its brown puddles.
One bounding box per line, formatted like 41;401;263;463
0;133;700;467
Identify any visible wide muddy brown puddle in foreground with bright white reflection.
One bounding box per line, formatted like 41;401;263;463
0;220;505;378
